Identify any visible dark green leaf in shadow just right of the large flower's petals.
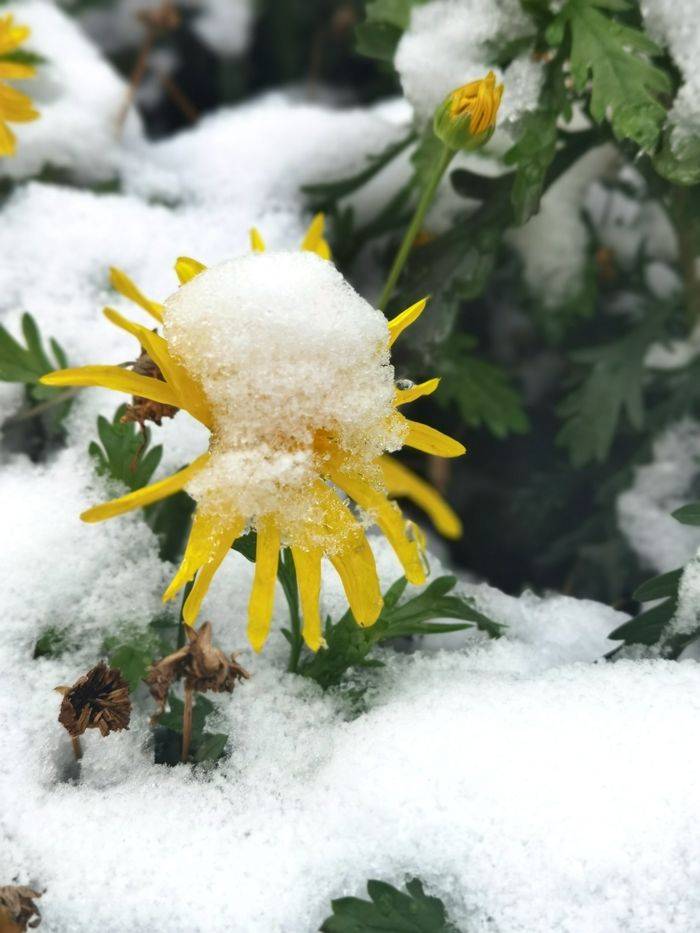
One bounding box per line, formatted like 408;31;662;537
436;334;529;437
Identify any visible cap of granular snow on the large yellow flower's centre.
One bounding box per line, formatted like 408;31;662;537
164;251;406;543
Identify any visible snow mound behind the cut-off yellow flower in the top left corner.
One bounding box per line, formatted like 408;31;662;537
0;0;141;182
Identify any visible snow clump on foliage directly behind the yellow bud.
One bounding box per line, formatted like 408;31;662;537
394;0;543;124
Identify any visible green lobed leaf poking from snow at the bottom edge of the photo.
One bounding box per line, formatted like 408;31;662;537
321;878;459;933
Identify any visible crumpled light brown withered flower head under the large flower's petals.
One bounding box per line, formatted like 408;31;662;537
145;622;250;713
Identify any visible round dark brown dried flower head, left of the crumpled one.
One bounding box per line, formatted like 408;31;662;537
56;661;131;738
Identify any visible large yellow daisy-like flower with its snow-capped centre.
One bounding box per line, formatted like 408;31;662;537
42;215;464;651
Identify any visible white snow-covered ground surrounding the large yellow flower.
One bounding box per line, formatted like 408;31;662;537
0;9;700;933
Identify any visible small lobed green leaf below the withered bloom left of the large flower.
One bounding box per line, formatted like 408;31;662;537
88;405;163;490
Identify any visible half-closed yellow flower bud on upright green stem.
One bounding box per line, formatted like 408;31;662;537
433;71;503;150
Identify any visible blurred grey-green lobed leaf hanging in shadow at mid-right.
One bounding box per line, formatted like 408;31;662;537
557;315;662;467
